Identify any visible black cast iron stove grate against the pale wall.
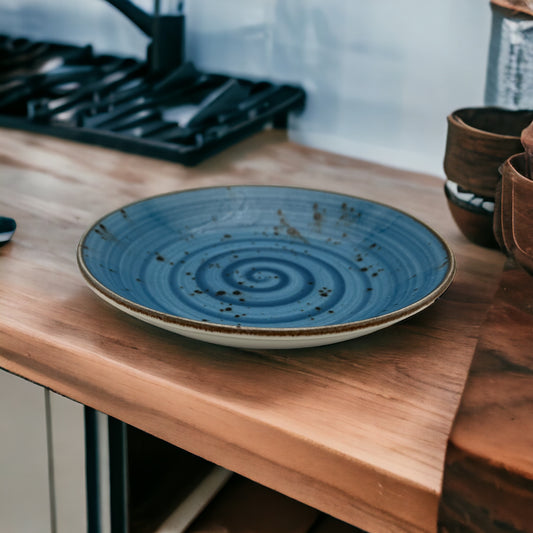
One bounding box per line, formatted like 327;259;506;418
0;36;305;165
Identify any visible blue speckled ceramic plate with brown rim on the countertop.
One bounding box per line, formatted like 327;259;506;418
78;186;455;348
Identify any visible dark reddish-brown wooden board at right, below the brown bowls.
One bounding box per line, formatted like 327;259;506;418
439;262;533;533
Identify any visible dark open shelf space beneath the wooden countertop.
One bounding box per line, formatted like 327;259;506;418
110;421;362;533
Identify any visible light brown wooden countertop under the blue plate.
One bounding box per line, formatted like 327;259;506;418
0;130;503;533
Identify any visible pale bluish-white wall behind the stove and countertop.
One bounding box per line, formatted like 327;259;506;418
0;0;491;176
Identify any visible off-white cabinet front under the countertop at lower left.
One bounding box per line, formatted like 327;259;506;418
0;370;86;533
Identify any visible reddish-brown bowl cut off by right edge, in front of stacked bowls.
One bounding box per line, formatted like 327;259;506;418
494;153;533;275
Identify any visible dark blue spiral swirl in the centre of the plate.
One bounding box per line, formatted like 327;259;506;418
164;241;345;327
